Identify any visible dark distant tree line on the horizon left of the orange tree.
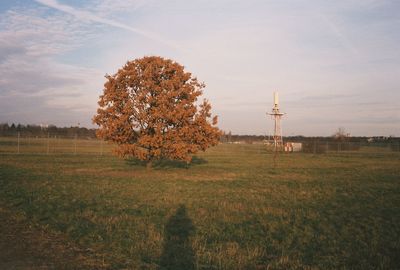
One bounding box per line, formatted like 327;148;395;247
0;123;96;139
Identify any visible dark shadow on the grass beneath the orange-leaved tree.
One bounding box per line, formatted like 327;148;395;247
126;156;208;169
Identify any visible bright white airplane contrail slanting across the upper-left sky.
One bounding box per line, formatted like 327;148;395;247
35;0;179;49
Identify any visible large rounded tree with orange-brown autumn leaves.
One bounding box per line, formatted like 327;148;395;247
93;56;221;166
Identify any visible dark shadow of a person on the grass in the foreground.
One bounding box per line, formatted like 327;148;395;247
160;205;195;270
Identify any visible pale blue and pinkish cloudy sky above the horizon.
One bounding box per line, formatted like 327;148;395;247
0;0;400;136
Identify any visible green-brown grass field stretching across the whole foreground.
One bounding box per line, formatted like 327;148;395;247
0;140;400;269
